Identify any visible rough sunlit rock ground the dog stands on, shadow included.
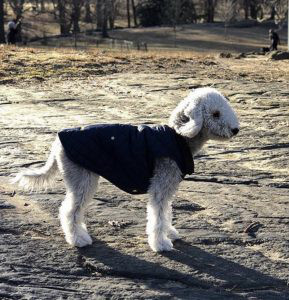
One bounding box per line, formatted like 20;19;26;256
0;55;289;299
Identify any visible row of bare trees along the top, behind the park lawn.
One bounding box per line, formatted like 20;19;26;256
0;0;288;42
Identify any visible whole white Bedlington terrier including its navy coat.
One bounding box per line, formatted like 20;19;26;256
14;88;239;252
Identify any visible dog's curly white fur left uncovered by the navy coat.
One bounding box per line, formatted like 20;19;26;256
14;88;239;252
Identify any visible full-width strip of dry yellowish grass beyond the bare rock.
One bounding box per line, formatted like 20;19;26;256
0;46;289;83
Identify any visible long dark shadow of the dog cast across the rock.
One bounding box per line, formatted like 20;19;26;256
79;240;289;299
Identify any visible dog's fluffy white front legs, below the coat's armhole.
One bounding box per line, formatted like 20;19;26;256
147;159;181;252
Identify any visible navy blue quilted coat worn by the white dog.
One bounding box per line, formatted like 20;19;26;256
58;124;194;194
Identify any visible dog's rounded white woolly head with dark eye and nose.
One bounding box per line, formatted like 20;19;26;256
170;88;240;139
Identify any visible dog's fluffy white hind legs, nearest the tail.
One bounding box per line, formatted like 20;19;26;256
59;150;99;247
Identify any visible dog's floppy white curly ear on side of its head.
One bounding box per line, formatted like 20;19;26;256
170;102;203;138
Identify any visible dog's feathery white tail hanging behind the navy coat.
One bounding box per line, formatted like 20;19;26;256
12;140;58;191
